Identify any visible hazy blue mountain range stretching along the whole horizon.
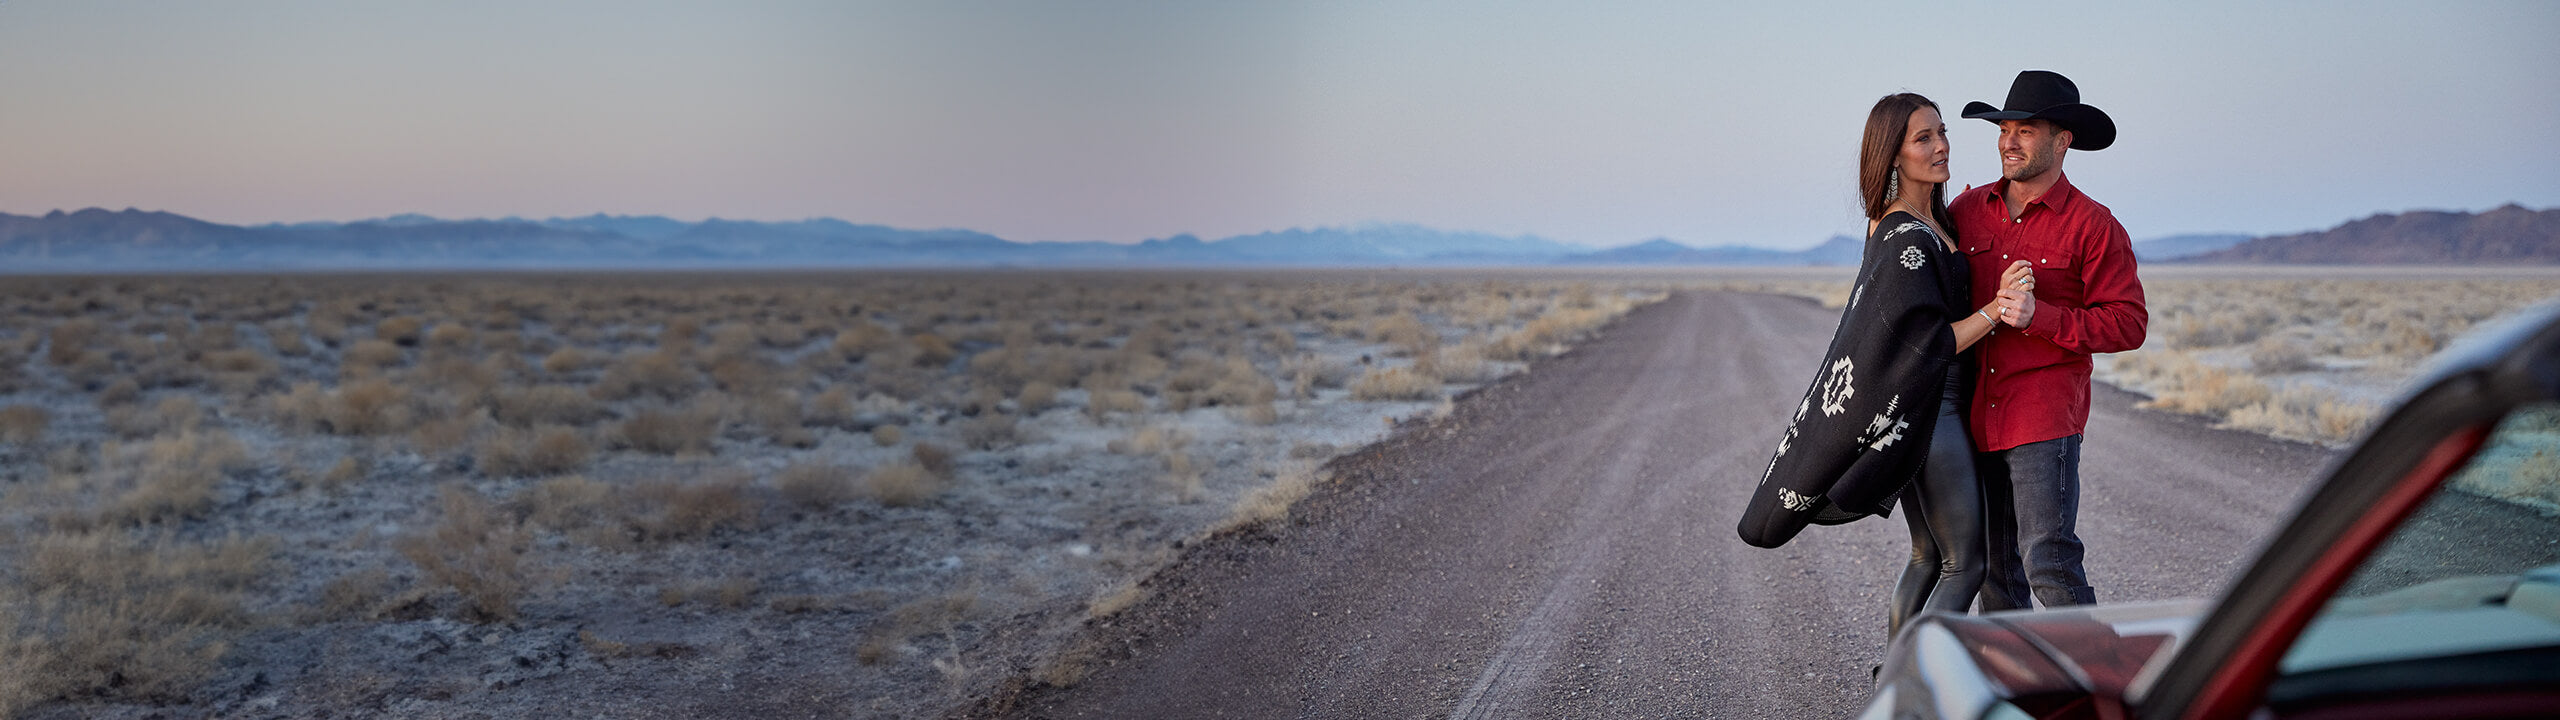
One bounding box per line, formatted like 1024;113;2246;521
0;205;2560;272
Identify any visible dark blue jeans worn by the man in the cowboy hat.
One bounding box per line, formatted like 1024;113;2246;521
1974;436;2097;612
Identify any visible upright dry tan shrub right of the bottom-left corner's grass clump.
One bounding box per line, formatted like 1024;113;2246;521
392;484;535;620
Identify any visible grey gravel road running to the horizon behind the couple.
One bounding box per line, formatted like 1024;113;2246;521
980;292;2330;717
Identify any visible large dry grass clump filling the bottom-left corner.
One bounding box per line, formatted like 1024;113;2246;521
0;530;274;717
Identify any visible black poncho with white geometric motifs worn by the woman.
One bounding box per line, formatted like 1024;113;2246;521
1741;213;1971;548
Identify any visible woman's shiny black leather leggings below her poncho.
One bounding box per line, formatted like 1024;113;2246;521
1887;369;1984;638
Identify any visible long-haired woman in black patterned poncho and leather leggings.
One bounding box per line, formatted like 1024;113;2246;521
1738;92;2033;633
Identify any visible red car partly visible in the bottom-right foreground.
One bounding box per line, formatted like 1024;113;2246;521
1861;305;2560;720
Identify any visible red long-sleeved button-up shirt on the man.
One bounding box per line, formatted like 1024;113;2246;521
1946;177;2150;451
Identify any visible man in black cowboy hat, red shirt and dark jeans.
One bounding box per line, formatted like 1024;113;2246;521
1948;69;2150;610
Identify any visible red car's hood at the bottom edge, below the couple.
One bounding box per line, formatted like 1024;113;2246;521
1871;600;2212;717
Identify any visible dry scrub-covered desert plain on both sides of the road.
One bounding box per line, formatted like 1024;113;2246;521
0;266;2560;717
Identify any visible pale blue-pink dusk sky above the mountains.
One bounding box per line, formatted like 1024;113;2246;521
0;0;2560;249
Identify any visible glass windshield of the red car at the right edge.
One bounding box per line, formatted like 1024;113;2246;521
2273;402;2560;676
